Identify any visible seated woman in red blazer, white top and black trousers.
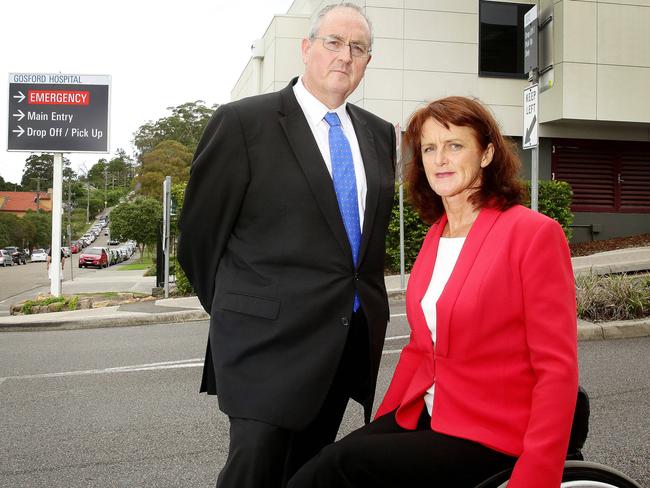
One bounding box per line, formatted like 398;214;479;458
289;97;578;488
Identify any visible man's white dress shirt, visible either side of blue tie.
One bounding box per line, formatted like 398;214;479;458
293;76;368;231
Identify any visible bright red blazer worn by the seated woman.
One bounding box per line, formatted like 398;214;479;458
377;206;578;488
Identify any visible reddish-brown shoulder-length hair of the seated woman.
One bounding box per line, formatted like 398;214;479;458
405;97;523;224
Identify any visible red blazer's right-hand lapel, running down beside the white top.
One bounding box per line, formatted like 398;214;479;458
432;208;501;356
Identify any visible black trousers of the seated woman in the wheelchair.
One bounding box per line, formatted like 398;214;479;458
288;409;517;488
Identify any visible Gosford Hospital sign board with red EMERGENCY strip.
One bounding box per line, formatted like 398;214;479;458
7;73;111;153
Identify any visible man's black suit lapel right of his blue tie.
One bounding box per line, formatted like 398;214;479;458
347;104;379;265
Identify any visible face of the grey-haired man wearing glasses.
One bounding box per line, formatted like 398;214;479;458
302;7;370;108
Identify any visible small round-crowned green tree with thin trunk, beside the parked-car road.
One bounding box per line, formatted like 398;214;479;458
110;197;162;259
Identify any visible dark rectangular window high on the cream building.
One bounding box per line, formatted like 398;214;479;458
479;0;533;78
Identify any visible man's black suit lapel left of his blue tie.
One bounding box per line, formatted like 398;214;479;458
279;78;352;263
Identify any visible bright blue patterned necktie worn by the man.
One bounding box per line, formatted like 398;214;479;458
325;112;361;312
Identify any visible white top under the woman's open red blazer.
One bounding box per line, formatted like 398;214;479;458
420;237;465;415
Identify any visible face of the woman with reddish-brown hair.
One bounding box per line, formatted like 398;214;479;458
420;118;494;202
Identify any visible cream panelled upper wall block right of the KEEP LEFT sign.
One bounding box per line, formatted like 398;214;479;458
540;0;650;126
